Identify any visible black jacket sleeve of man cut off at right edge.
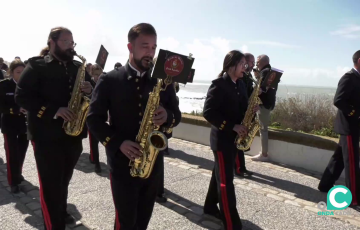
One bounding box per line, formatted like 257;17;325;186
334;75;360;116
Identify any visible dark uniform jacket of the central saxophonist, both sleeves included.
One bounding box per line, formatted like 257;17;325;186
87;63;181;168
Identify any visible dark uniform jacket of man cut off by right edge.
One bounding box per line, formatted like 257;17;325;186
334;69;360;135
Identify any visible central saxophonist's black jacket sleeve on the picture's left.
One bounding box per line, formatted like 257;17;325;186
86;76;124;152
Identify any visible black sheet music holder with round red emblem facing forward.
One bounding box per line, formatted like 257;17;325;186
152;49;195;84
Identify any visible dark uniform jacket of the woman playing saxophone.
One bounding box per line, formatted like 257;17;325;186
204;74;248;151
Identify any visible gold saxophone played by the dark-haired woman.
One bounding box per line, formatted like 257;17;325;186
235;72;262;151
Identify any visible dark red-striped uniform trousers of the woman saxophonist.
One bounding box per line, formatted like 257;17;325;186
204;146;242;230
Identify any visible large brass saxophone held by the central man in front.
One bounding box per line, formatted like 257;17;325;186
130;62;171;179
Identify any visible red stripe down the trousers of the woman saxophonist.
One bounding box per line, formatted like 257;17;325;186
217;152;232;230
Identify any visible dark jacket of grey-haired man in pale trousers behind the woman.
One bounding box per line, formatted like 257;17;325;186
259;65;277;110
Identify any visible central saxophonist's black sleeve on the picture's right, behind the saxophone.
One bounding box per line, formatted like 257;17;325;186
160;82;181;128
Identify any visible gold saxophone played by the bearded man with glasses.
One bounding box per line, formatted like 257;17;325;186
63;50;90;136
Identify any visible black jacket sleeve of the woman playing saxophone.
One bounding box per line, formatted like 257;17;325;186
204;83;235;132
